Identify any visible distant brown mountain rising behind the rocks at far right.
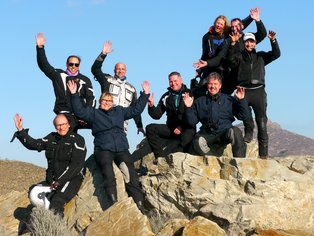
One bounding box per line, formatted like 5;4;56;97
239;120;314;157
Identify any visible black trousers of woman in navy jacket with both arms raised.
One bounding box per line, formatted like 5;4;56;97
95;150;143;202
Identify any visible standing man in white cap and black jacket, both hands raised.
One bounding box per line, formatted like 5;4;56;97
228;31;280;159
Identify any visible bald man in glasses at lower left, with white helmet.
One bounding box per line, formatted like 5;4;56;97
11;114;86;216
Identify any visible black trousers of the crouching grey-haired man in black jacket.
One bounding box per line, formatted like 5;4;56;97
146;124;195;158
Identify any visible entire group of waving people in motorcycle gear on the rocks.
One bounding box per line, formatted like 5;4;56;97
10;8;280;215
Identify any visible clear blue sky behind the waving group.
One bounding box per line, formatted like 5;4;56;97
0;0;314;166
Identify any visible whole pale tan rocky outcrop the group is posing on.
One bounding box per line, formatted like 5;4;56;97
0;142;314;236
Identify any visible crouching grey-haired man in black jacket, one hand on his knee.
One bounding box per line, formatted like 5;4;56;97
146;72;195;164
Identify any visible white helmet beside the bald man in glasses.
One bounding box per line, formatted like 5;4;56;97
29;185;51;210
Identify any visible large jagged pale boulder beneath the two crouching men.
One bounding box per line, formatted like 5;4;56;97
141;153;314;235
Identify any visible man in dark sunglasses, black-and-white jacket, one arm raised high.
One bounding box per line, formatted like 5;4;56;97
36;33;96;132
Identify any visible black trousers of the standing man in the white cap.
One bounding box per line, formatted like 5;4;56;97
245;87;268;156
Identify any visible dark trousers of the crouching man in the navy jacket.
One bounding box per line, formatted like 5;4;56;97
193;126;246;157
